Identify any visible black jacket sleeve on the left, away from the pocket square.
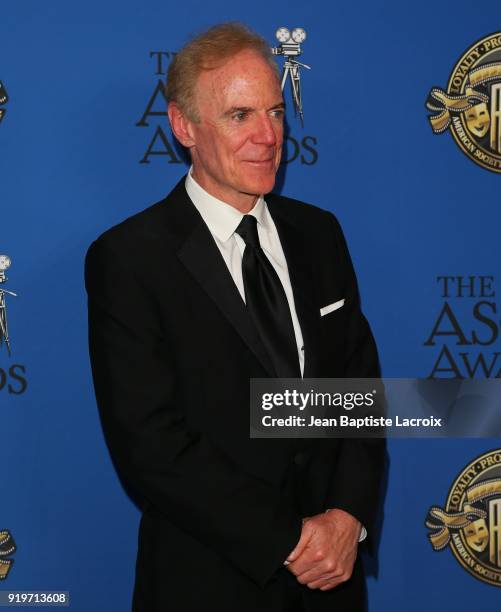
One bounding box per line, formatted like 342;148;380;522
85;238;301;586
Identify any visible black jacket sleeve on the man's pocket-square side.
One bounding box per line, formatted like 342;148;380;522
320;214;386;541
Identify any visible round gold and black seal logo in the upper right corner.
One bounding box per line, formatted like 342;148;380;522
426;32;501;172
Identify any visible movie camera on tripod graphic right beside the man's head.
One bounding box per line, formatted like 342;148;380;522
271;28;311;124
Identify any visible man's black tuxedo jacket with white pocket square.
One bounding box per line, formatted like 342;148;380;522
86;179;384;612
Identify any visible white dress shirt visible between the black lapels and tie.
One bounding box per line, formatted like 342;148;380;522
185;168;304;376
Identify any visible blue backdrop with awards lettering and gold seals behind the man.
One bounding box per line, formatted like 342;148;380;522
0;0;501;612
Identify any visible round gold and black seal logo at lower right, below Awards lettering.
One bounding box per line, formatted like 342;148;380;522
426;449;501;587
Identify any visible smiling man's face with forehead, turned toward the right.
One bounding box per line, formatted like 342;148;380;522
190;50;284;212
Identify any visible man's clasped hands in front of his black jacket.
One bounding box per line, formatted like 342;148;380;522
287;508;361;591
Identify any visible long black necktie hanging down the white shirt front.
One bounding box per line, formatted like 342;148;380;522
235;215;301;378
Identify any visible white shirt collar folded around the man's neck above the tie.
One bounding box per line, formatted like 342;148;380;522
185;166;267;242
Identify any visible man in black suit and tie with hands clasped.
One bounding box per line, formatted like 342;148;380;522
86;24;384;612
